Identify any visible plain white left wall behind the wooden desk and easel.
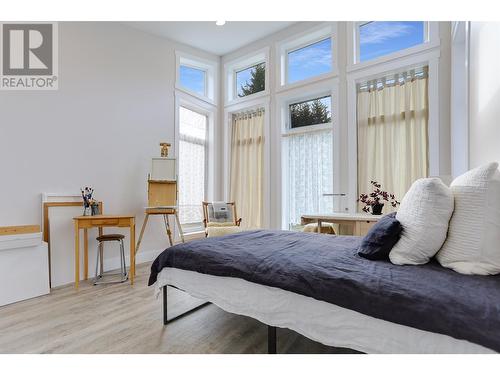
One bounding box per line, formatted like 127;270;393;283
0;22;219;284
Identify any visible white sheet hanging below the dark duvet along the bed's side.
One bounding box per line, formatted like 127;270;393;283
156;268;494;353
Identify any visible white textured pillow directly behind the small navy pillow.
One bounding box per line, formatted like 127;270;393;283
389;178;453;264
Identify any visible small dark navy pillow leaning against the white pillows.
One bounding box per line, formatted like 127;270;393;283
358;212;402;260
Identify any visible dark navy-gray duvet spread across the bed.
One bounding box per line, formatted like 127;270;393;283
149;230;500;352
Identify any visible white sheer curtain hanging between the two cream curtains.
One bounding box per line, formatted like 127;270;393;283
286;126;333;229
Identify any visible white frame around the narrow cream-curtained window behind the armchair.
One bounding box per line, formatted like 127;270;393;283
223;94;273;228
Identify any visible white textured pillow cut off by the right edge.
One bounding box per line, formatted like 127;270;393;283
436;163;500;275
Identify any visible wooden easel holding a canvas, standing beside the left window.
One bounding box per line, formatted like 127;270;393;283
135;143;184;254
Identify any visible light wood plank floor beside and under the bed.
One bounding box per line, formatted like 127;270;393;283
0;263;360;353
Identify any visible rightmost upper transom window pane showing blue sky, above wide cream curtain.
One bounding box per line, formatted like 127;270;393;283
358;21;426;62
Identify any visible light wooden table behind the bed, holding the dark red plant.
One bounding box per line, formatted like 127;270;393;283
301;213;382;236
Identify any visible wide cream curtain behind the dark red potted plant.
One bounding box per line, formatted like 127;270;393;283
357;69;428;212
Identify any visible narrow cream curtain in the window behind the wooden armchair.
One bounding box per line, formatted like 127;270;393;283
230;110;264;229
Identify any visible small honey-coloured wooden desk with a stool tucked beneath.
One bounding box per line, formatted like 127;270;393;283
73;215;135;289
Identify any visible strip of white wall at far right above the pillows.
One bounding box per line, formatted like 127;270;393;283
464;22;500;168
